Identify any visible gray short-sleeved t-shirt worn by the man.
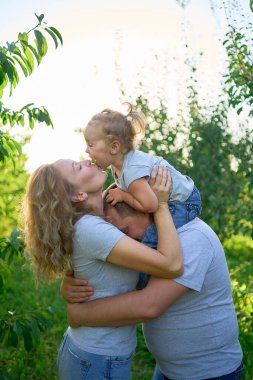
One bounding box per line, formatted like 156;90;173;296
143;218;242;380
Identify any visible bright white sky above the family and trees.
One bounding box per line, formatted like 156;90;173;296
0;0;252;170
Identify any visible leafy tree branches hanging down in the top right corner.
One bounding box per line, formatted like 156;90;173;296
176;0;253;116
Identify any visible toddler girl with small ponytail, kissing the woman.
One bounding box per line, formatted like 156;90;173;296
84;107;201;233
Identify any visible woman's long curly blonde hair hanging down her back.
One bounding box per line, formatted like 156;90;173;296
23;164;76;281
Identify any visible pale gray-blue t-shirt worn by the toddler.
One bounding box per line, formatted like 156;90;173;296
113;150;194;202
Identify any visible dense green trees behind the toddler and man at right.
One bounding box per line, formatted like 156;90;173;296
136;91;253;240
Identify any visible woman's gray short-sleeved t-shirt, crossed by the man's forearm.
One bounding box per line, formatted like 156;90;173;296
68;215;139;355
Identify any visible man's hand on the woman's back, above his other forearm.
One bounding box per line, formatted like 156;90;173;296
61;269;94;303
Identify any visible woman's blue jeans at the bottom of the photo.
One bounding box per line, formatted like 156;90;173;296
57;333;133;380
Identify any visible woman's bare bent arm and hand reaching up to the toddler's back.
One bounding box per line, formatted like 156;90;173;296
107;166;183;278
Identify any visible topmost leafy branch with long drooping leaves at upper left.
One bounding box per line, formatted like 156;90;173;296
0;15;63;99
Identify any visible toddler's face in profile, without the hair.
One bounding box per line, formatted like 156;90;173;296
84;126;113;169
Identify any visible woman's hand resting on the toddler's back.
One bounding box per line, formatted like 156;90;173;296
149;165;171;204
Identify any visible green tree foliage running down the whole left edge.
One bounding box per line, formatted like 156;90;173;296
0;15;63;372
